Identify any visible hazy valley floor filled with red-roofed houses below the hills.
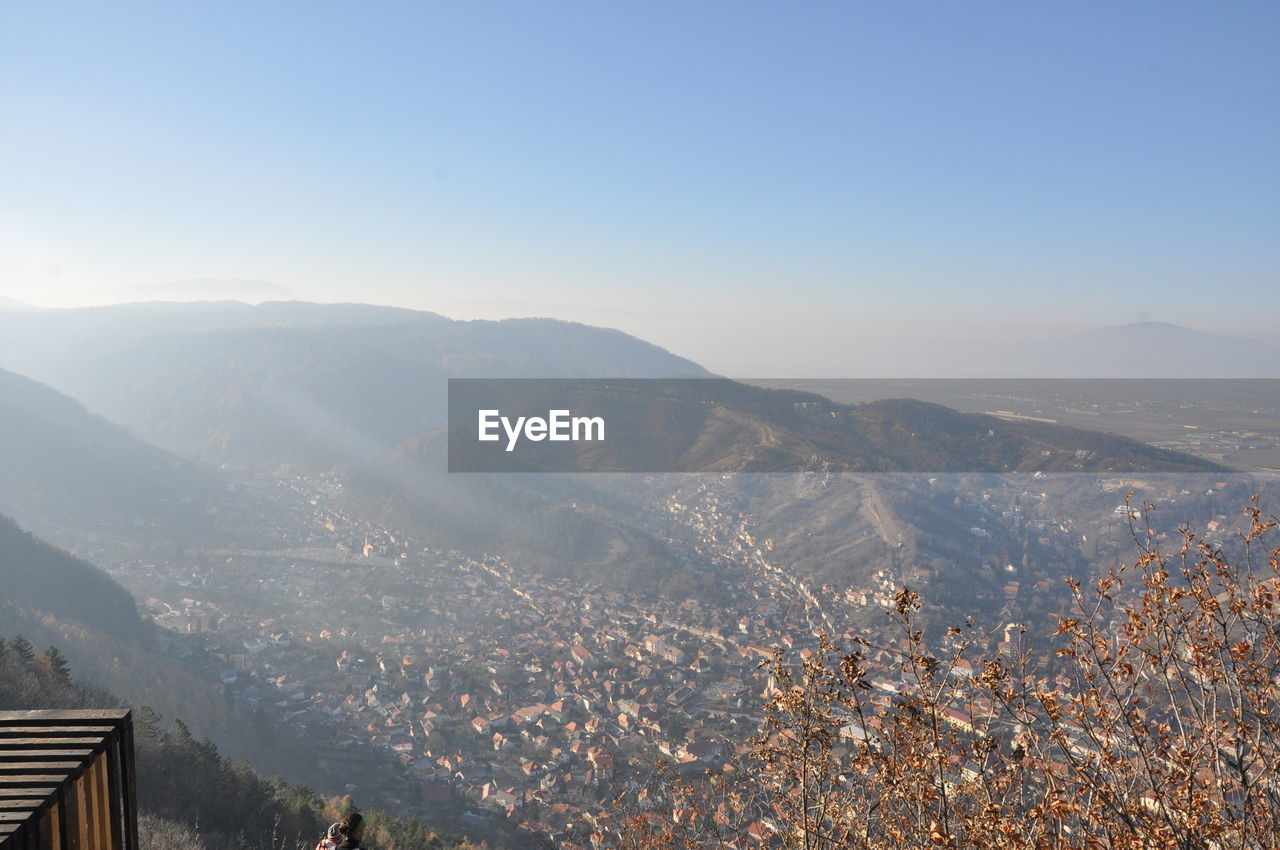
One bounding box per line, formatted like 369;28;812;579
82;460;1269;846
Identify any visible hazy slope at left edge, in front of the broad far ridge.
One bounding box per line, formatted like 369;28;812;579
0;370;225;541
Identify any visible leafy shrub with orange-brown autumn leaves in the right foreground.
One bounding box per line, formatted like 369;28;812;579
604;499;1280;850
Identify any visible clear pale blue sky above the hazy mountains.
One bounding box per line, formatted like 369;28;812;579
0;0;1280;375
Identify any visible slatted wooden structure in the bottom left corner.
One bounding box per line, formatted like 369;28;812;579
0;709;138;850
